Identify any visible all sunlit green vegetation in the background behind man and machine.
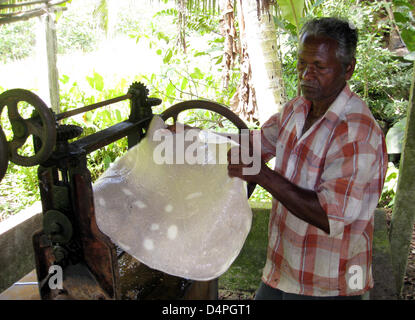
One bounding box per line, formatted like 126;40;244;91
0;0;414;218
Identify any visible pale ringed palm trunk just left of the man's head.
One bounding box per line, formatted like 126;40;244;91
237;0;285;124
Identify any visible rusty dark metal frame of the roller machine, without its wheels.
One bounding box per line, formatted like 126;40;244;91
33;83;154;299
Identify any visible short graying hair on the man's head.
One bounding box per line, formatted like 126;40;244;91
300;18;358;67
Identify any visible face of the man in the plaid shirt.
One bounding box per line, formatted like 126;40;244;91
297;34;354;104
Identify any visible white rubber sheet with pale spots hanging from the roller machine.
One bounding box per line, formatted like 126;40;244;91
94;116;252;281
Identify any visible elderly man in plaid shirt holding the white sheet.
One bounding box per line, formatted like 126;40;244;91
228;18;387;299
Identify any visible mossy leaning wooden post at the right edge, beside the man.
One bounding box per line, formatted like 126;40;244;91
390;61;415;295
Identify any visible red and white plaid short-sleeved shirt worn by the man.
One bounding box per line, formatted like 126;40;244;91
257;85;388;296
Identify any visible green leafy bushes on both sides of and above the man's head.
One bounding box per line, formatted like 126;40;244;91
276;1;411;127
